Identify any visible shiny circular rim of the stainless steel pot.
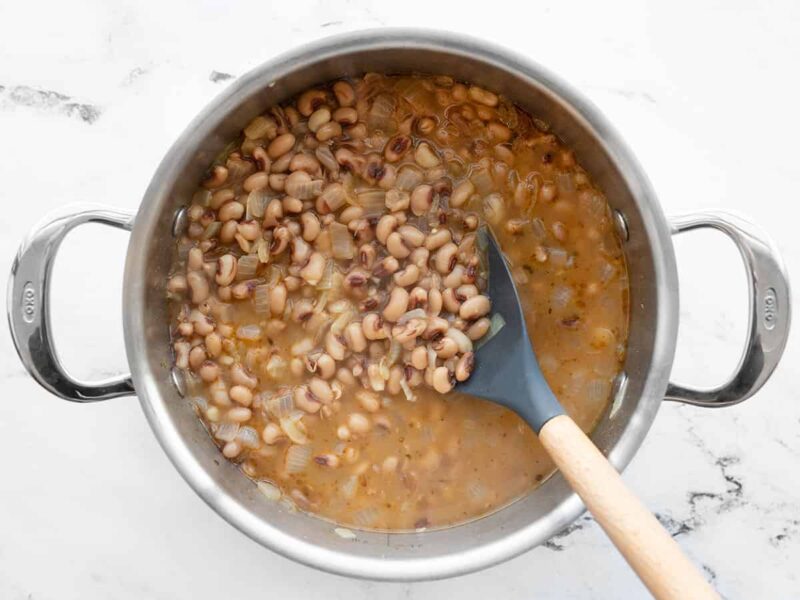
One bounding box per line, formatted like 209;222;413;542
123;29;678;581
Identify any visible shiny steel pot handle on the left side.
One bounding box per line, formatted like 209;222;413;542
8;204;135;402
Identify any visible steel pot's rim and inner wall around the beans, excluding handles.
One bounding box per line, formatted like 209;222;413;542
125;32;677;579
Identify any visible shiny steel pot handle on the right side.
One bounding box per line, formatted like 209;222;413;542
666;211;791;407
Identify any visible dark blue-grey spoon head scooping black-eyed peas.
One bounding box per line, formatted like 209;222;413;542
455;227;563;432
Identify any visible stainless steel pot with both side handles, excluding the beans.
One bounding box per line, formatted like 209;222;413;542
8;30;790;580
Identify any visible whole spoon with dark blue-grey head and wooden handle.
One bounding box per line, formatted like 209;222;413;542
456;228;719;600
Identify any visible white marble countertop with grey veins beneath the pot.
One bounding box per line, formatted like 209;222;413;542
0;0;800;600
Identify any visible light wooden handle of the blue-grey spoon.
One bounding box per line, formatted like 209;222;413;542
539;415;719;600
